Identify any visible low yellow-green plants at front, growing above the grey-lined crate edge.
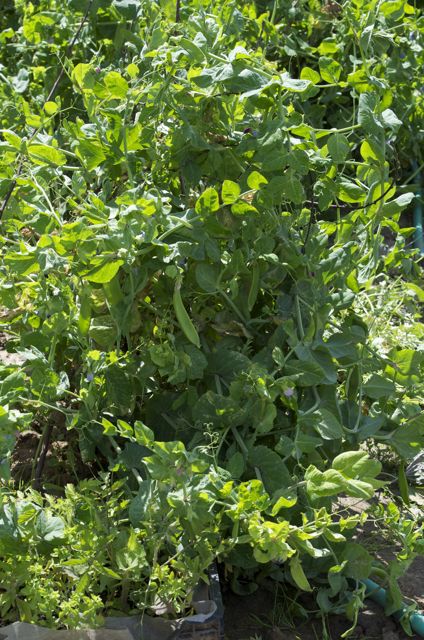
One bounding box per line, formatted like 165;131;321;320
0;423;384;628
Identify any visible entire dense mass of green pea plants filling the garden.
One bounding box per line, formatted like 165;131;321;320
0;0;424;627
